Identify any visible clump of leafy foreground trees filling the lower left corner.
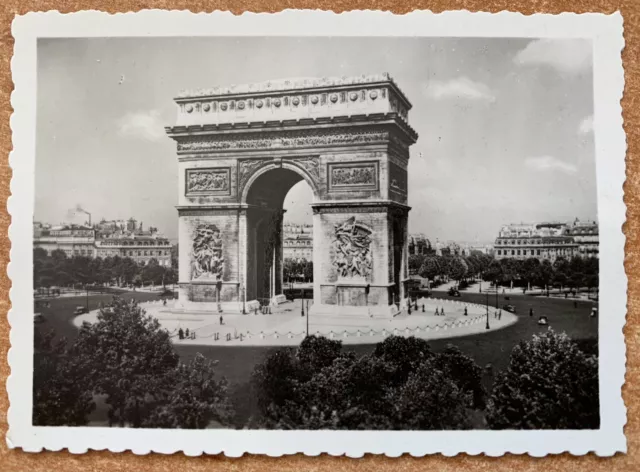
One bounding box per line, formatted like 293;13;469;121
33;298;234;428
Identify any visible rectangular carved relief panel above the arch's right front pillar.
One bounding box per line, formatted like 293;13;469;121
327;161;380;192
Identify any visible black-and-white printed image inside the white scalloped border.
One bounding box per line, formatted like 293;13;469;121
8;10;626;458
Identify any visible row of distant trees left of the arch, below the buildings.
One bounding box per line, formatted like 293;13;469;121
33;248;178;288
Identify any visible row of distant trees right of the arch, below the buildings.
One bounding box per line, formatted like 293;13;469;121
409;252;598;289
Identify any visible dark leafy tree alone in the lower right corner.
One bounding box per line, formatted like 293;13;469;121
487;330;600;429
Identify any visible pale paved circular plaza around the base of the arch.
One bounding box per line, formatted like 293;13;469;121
73;298;518;346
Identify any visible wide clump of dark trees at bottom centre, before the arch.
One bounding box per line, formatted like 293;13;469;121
252;336;481;430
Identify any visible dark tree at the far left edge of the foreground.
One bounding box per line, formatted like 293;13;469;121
32;329;95;426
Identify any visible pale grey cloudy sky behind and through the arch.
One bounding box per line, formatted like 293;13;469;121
34;37;597;243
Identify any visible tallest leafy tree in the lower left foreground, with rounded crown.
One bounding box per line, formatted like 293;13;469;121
76;298;178;427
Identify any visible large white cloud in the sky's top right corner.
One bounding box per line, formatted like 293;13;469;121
513;39;592;73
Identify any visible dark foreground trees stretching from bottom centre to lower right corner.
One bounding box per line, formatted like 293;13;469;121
251;331;599;430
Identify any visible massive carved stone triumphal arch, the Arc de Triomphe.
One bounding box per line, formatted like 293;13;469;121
166;74;417;315
